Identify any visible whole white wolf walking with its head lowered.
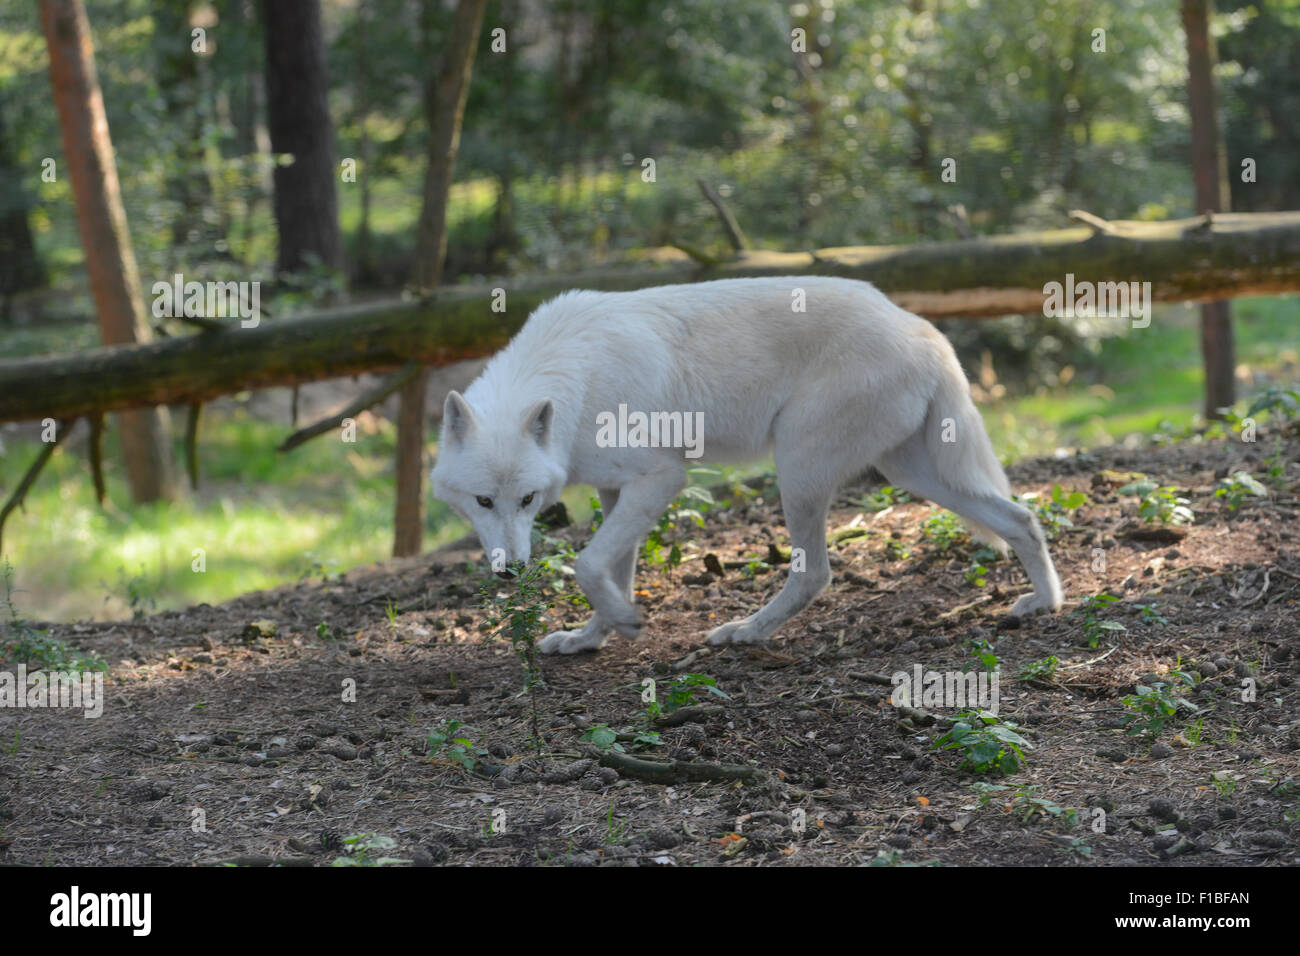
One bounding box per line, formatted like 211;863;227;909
433;277;1061;654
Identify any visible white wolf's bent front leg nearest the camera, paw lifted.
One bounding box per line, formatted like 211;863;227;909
577;460;686;637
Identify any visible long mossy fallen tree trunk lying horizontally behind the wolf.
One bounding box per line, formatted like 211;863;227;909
0;212;1300;421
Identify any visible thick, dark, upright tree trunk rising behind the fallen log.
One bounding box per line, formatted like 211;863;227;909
261;0;343;273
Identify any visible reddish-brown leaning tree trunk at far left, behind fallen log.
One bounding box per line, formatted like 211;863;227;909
40;0;177;502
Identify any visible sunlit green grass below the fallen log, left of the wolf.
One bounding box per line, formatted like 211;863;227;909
0;411;460;619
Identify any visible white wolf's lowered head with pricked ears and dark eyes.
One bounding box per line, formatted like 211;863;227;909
432;392;566;572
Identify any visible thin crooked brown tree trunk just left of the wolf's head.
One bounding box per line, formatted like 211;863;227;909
393;0;488;558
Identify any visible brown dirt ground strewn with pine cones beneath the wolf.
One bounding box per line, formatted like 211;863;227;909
0;434;1300;866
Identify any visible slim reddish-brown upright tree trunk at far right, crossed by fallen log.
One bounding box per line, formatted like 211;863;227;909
1183;0;1236;419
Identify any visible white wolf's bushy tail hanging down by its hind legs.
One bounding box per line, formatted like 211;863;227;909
926;341;1011;553
